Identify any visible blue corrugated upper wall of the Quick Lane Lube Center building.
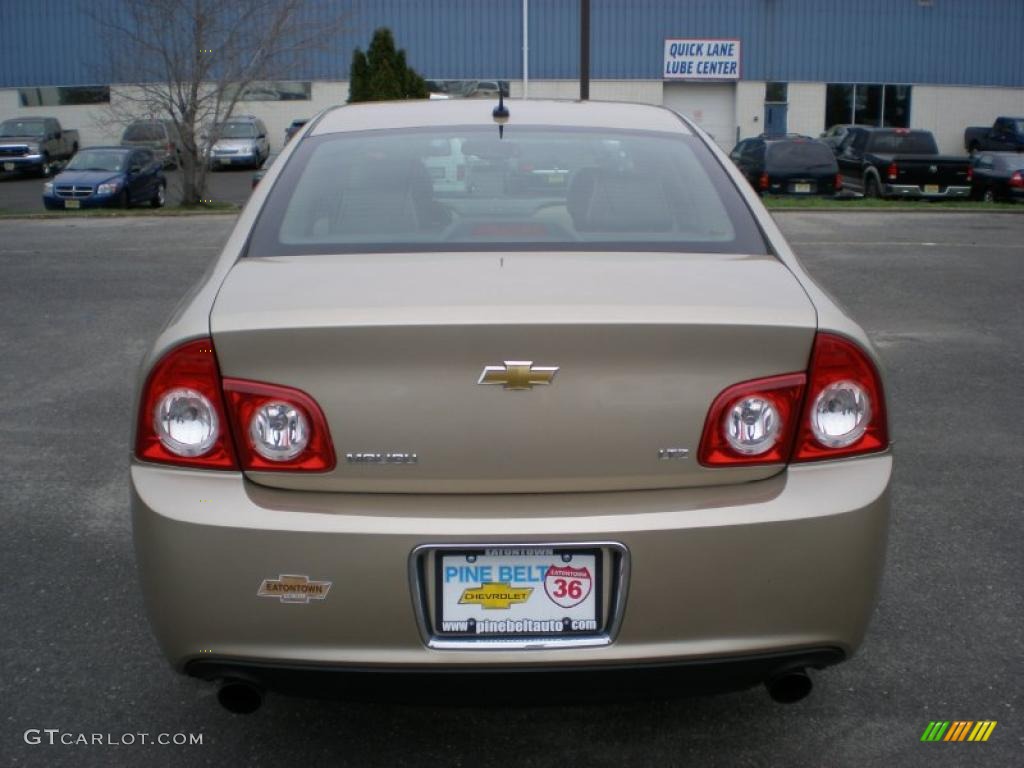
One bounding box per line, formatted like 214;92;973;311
0;0;1024;87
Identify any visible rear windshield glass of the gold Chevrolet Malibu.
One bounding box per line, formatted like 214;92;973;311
249;126;766;256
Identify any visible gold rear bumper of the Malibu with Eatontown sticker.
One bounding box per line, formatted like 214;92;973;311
131;454;892;675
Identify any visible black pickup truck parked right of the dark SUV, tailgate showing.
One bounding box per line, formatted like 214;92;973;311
836;126;972;200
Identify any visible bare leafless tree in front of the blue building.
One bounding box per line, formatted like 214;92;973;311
89;0;344;205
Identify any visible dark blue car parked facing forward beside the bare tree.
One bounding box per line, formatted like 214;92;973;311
43;146;167;210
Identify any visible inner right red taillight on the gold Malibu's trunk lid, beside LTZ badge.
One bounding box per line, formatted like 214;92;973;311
697;373;807;467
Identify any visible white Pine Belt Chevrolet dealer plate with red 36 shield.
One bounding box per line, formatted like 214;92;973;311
435;548;602;640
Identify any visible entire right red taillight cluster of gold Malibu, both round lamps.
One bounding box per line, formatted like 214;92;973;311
697;333;889;467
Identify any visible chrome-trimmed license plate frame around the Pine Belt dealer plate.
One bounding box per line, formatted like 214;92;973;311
409;542;630;650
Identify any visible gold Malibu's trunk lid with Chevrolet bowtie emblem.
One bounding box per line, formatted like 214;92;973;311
211;252;816;493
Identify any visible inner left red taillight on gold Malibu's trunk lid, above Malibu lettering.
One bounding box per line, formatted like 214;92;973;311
224;379;335;472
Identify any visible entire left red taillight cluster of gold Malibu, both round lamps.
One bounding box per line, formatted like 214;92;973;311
135;339;335;472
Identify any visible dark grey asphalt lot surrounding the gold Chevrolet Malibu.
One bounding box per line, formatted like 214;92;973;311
0;211;1024;768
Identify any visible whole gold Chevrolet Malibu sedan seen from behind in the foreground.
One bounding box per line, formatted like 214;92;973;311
130;99;893;712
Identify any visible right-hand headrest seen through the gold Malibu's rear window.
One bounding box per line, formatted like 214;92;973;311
566;168;675;232
